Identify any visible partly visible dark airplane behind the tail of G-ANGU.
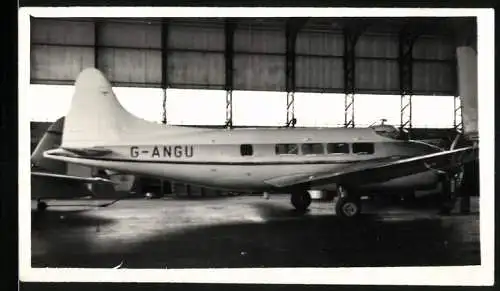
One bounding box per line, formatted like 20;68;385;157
31;117;115;211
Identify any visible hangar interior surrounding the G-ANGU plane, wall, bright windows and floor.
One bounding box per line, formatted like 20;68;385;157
30;17;484;269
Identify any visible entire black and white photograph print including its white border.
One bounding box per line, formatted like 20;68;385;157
19;7;494;285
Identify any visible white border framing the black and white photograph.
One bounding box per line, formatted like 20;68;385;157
18;7;495;286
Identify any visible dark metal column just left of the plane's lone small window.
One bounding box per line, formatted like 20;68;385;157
224;19;235;128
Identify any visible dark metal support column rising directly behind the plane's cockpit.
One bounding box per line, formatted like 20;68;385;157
399;29;417;135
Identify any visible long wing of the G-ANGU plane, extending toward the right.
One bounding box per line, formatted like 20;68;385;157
265;147;478;188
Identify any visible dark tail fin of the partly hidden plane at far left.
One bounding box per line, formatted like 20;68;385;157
31;117;67;174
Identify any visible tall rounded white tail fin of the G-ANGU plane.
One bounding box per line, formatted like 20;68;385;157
61;68;151;148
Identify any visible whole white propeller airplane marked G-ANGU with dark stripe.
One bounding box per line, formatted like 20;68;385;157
44;68;478;218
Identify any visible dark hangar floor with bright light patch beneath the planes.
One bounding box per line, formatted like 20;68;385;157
31;195;481;268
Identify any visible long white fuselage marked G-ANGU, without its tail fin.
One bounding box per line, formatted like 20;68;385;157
45;128;444;191
